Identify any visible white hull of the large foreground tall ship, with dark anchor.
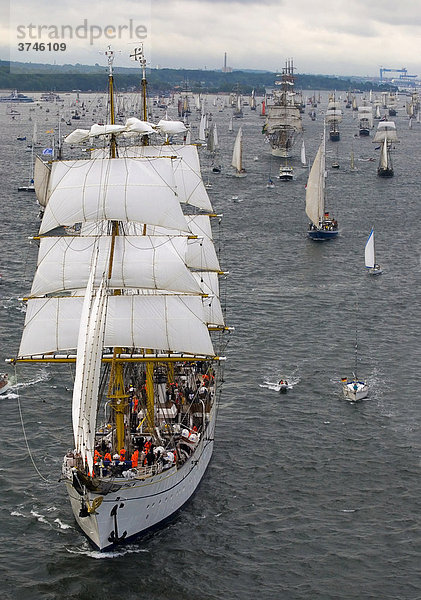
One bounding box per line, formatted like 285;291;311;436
66;408;215;550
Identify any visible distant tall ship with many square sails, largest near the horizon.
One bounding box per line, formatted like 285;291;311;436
263;59;303;158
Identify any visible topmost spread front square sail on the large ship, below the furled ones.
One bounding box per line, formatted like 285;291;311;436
40;158;187;234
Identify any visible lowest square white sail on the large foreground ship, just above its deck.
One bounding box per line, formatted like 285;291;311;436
19;295;214;357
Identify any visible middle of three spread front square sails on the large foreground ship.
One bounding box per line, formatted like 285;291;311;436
31;235;200;296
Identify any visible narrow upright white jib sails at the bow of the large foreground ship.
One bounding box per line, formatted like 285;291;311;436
72;258;106;472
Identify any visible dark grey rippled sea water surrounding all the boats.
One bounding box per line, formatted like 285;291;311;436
0;94;421;600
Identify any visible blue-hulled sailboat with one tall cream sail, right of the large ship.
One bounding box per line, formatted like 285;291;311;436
306;131;338;240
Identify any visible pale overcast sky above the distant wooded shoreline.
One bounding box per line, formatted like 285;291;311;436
0;0;421;76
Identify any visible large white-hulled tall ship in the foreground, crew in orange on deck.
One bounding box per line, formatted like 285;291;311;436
12;48;226;550
